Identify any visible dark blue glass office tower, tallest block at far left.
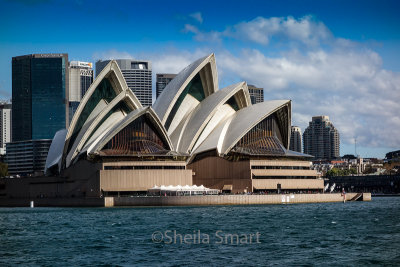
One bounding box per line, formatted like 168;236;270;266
12;54;69;142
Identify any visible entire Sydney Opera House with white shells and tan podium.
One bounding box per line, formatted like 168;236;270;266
3;54;323;200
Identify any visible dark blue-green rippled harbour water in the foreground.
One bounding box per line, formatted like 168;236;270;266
0;197;400;266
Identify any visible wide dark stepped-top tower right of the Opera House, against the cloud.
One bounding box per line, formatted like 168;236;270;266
303;116;340;159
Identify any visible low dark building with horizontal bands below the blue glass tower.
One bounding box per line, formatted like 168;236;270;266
6;139;52;176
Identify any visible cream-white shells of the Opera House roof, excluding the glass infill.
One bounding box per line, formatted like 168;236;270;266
46;54;291;171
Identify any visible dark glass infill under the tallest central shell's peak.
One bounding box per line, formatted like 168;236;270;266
165;73;206;130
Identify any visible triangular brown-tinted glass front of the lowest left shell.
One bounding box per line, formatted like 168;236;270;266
100;115;169;156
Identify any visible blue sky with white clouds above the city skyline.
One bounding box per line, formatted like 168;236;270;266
0;0;400;157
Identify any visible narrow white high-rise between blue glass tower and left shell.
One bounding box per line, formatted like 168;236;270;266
69;61;94;122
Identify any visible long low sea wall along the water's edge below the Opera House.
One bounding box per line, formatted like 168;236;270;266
0;193;371;207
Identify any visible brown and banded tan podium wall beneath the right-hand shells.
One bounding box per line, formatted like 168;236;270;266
187;157;324;193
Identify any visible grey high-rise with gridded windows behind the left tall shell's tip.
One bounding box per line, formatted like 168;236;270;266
96;59;153;106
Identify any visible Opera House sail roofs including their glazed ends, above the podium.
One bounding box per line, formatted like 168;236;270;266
46;54;307;176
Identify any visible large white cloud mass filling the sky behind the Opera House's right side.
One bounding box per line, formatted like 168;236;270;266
91;16;400;152
